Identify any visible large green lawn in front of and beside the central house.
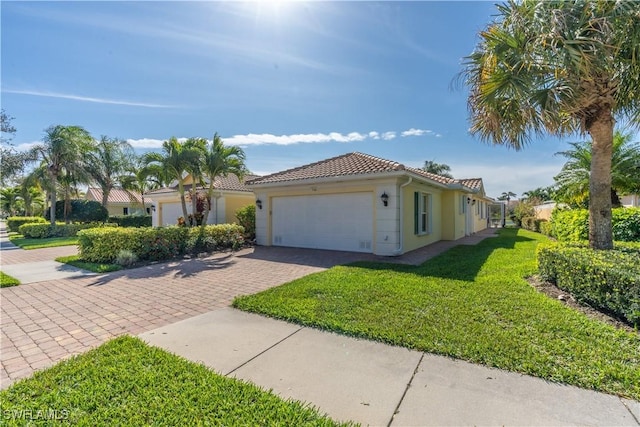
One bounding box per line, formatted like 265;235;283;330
233;229;640;400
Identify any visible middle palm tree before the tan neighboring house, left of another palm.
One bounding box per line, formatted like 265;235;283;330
145;137;202;224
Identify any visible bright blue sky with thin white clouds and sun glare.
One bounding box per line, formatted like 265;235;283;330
0;1;576;197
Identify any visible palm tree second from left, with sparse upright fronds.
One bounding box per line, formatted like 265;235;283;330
86;136;133;208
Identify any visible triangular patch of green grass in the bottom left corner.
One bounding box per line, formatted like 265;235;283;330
0;336;352;426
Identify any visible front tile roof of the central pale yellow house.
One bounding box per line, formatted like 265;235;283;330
247;152;453;185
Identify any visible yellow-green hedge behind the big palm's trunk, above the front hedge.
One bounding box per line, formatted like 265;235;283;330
551;208;640;242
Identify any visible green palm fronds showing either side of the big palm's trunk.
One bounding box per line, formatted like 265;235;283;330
554;131;640;206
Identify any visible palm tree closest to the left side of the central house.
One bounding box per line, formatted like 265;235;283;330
201;133;247;226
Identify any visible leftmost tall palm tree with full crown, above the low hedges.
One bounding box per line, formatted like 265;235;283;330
35;125;93;225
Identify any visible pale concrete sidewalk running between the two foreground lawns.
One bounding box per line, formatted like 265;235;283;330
140;308;640;426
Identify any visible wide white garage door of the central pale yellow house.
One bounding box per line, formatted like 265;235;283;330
271;193;373;252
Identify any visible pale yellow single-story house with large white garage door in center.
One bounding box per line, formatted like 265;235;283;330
247;153;493;256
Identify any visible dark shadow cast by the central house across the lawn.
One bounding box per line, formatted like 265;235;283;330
349;229;533;282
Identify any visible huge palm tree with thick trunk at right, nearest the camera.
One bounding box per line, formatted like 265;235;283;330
460;0;640;249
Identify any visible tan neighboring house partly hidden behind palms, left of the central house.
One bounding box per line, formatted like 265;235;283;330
145;174;258;227
